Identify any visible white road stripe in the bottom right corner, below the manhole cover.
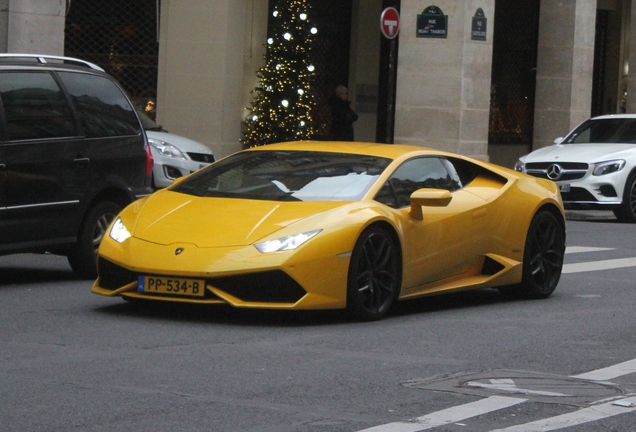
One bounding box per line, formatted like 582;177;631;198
491;397;636;432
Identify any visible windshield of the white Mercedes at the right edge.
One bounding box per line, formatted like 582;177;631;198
562;118;636;144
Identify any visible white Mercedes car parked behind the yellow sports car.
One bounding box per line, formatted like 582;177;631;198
515;114;636;223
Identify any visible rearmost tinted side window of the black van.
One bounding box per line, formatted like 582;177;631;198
59;72;141;138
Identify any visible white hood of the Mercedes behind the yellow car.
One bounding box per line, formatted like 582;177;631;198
521;144;636;163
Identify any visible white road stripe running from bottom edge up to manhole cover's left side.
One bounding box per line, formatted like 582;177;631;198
359;396;526;432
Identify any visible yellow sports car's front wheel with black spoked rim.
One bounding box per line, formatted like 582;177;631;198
347;227;401;321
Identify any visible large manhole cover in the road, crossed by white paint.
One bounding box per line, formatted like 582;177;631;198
402;370;626;406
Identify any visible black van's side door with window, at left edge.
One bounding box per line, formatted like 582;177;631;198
0;70;88;248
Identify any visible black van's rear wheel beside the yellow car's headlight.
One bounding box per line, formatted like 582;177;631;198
67;201;121;279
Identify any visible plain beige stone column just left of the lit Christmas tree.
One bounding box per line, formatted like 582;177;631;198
157;0;251;158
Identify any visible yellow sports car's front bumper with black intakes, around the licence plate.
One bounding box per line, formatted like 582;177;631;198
91;233;350;309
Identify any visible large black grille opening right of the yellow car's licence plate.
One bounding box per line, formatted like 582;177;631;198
209;270;307;303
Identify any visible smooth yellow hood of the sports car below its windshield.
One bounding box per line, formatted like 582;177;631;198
124;190;347;247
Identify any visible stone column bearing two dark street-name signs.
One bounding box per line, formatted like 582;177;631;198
394;0;495;159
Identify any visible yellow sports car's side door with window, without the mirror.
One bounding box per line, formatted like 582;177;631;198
376;157;488;296
